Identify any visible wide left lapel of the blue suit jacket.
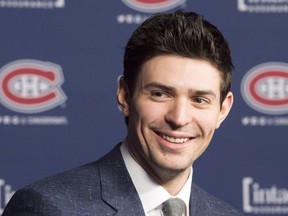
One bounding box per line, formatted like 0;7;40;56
98;144;145;216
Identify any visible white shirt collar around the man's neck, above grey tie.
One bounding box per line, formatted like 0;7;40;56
120;141;193;215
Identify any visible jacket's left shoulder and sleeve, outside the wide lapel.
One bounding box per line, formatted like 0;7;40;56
3;144;123;216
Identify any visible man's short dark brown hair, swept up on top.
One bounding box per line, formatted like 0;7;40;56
124;11;233;104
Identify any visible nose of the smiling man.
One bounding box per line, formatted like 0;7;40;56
165;98;192;128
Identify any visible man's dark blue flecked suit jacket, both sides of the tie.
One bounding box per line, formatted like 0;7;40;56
2;145;241;216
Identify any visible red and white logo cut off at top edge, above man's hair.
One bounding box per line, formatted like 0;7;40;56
122;0;186;13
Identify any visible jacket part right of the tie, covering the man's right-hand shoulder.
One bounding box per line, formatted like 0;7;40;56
191;184;243;216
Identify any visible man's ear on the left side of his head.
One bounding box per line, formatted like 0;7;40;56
117;76;130;116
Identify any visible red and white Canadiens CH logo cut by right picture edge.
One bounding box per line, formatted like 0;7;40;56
241;62;288;115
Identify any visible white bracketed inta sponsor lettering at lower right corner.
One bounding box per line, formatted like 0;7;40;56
242;177;288;215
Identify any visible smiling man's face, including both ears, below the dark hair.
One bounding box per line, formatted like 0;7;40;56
118;55;233;181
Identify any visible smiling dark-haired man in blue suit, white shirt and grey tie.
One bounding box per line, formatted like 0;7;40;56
3;11;241;216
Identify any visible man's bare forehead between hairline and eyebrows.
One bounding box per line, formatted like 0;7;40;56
137;55;221;93
